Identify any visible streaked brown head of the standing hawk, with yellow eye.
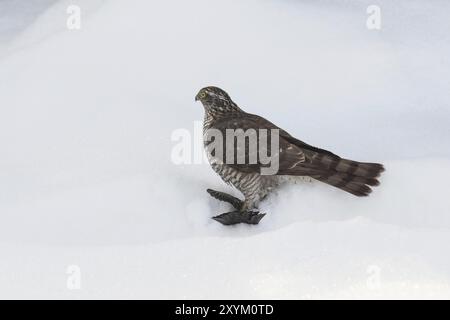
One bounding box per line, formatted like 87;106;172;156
195;87;241;114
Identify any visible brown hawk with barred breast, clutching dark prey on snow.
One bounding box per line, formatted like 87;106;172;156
195;86;384;225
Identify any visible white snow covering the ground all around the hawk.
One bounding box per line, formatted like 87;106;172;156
0;0;450;299
